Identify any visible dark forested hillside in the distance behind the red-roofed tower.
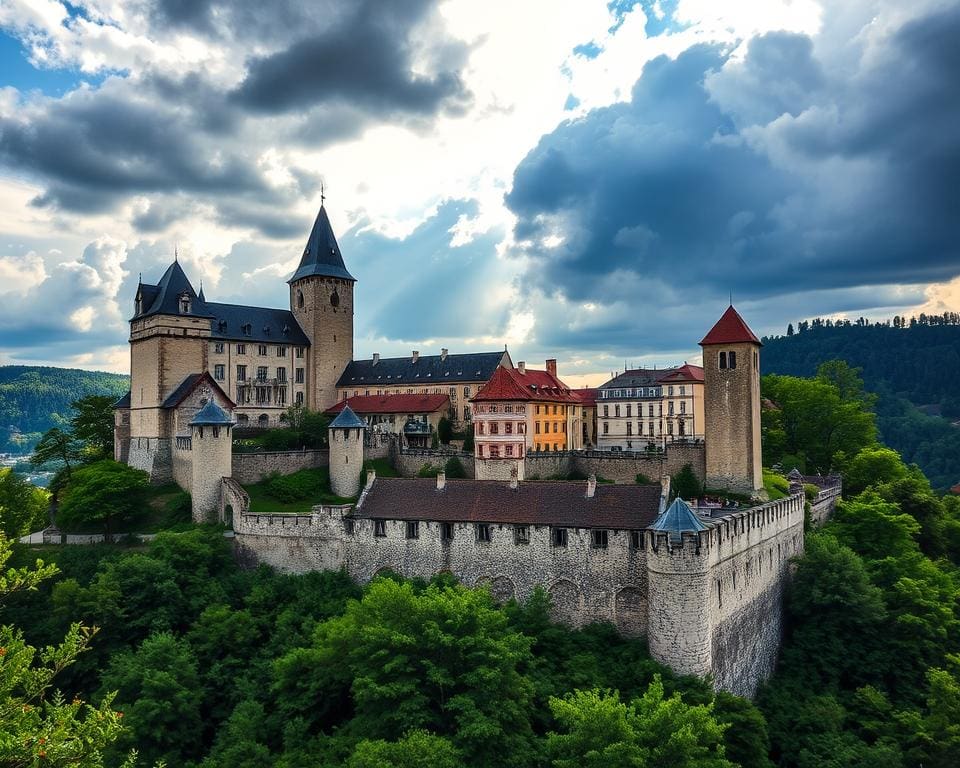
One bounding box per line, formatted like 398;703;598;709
762;313;960;490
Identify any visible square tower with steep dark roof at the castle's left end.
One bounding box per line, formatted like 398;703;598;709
127;261;211;483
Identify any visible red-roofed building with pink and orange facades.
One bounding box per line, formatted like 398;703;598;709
471;360;584;479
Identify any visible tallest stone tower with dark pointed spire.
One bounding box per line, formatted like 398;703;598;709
287;205;356;411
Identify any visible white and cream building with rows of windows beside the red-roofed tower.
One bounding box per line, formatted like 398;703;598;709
596;364;704;451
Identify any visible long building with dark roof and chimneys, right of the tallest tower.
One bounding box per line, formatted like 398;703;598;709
337;348;513;429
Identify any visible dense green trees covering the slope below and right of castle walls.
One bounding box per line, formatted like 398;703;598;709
0;361;960;768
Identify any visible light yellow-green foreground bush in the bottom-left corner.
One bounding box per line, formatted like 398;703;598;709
0;536;123;768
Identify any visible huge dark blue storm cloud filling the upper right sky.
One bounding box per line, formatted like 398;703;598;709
507;8;960;316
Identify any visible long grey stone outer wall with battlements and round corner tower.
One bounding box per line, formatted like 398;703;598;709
233;489;804;696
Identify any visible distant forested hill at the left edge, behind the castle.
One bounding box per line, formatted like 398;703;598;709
0;365;130;453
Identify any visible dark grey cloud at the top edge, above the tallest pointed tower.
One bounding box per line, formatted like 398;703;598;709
232;0;468;114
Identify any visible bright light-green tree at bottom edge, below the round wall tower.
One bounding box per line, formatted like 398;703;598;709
547;675;734;768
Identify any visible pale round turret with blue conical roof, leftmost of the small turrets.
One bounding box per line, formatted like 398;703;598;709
190;400;233;523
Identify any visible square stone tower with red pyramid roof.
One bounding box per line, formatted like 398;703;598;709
700;304;763;494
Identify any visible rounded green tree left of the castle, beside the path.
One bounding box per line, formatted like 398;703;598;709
57;459;150;536
